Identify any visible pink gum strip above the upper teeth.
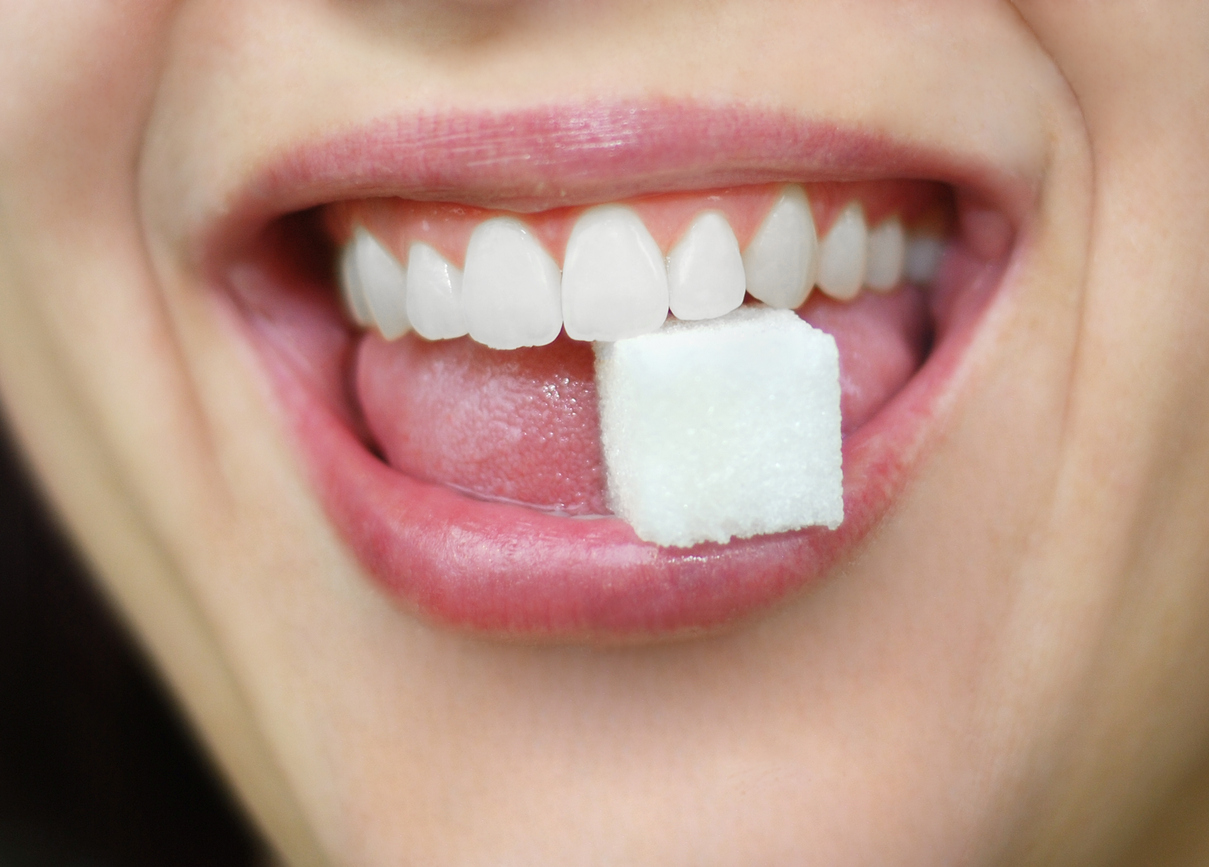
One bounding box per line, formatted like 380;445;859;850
324;180;949;267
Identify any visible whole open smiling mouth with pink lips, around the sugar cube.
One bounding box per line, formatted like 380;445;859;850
197;104;1030;641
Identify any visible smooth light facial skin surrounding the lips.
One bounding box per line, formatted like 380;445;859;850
0;0;1209;865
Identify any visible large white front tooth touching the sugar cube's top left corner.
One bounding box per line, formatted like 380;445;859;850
562;204;667;341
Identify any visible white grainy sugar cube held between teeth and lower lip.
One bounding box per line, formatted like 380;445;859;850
596;307;844;548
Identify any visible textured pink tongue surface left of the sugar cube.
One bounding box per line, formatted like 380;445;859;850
357;334;607;515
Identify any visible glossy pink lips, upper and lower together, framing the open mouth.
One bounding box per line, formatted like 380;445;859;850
199;104;1031;640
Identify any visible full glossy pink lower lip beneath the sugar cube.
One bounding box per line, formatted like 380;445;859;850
222;212;1003;641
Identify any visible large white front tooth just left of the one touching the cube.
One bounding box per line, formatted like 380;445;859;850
462;216;562;349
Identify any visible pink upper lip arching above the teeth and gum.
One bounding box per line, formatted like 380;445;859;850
189;102;1036;273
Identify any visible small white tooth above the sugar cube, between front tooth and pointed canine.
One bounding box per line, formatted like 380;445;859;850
667;210;747;319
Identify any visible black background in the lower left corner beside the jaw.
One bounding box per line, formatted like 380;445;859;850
0;426;267;867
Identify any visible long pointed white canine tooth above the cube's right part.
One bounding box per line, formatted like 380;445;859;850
744;186;818;310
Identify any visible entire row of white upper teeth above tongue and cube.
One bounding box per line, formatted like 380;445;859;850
337;184;943;349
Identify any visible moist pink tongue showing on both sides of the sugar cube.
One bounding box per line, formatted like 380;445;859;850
357;287;929;515
